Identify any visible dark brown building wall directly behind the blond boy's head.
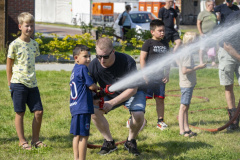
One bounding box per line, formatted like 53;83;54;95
5;0;35;43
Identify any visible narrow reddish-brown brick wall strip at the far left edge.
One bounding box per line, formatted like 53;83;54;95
0;0;5;48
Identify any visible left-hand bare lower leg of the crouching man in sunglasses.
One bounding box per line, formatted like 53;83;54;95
92;108;113;141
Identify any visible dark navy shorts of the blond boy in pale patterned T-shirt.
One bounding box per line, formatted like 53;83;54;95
10;83;43;112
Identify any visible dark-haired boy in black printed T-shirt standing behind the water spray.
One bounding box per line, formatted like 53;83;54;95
140;19;170;130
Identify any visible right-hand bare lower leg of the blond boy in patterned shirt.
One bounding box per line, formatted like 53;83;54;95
32;111;43;146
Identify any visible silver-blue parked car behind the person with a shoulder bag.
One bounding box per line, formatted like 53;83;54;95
113;11;157;37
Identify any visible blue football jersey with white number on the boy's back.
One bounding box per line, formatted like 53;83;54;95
70;64;94;116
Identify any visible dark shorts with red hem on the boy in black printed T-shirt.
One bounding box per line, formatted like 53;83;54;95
146;83;166;99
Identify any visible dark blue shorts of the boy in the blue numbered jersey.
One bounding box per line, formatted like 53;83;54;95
70;114;91;136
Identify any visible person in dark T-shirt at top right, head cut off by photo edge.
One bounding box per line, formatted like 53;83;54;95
214;0;239;24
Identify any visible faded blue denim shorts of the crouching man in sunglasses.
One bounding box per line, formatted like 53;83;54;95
94;91;146;113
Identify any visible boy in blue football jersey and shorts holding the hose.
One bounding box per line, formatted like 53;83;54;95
70;45;98;159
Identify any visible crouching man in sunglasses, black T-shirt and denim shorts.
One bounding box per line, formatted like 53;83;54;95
89;38;146;156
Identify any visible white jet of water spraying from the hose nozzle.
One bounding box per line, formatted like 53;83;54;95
109;22;240;92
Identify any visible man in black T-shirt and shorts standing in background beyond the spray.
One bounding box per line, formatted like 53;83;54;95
158;0;181;52
